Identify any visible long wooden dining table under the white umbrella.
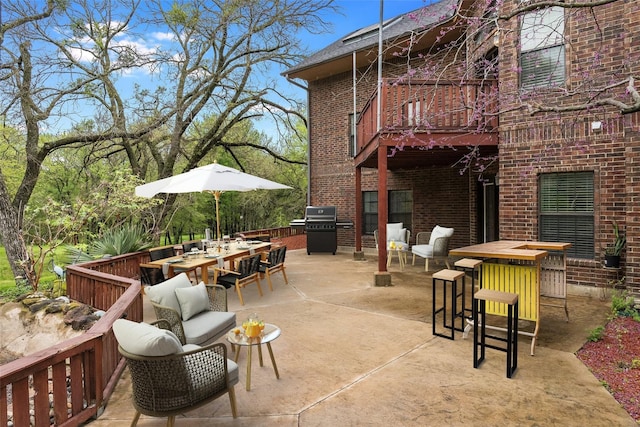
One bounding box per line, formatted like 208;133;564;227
146;240;271;284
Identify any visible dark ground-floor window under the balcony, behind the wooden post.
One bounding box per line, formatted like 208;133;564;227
362;190;413;234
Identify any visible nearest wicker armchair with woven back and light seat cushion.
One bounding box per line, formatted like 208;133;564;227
114;319;238;427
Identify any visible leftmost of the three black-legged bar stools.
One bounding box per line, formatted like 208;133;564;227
431;269;465;340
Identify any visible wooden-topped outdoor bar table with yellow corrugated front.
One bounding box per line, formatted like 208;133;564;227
449;240;571;356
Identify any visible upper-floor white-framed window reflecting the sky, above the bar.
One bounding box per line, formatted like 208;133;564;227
520;7;565;89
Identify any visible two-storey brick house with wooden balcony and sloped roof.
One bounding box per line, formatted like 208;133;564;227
285;0;640;293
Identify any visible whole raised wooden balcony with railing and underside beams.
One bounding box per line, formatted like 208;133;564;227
355;79;498;170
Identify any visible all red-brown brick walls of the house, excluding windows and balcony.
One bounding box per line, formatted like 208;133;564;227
302;1;640;286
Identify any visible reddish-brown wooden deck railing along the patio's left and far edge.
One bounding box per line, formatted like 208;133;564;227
0;227;298;427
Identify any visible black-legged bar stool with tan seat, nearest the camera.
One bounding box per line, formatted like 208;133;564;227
473;288;518;378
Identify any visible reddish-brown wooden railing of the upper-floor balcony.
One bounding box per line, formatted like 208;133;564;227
357;79;498;150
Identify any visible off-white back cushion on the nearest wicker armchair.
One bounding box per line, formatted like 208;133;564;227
113;319;182;356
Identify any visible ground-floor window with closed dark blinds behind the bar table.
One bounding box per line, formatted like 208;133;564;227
539;172;594;259
